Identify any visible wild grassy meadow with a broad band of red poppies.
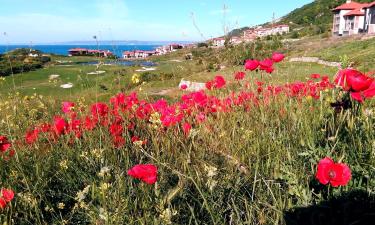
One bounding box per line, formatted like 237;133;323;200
0;37;375;224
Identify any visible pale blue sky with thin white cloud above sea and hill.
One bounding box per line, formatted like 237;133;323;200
0;0;312;44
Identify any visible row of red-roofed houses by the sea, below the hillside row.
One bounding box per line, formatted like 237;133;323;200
122;44;194;59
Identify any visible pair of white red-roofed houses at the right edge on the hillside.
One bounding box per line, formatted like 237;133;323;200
332;0;375;36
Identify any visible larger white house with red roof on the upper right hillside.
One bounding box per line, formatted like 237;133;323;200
332;0;368;36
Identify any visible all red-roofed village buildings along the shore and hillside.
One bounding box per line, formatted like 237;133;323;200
69;0;375;59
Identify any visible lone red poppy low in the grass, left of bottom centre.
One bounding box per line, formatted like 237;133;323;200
128;164;158;184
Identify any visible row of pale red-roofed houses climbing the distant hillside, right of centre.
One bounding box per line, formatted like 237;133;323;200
209;24;290;47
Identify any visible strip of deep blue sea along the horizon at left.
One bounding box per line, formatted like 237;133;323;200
0;45;159;57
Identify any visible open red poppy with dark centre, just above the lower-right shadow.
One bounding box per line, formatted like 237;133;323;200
316;157;351;187
